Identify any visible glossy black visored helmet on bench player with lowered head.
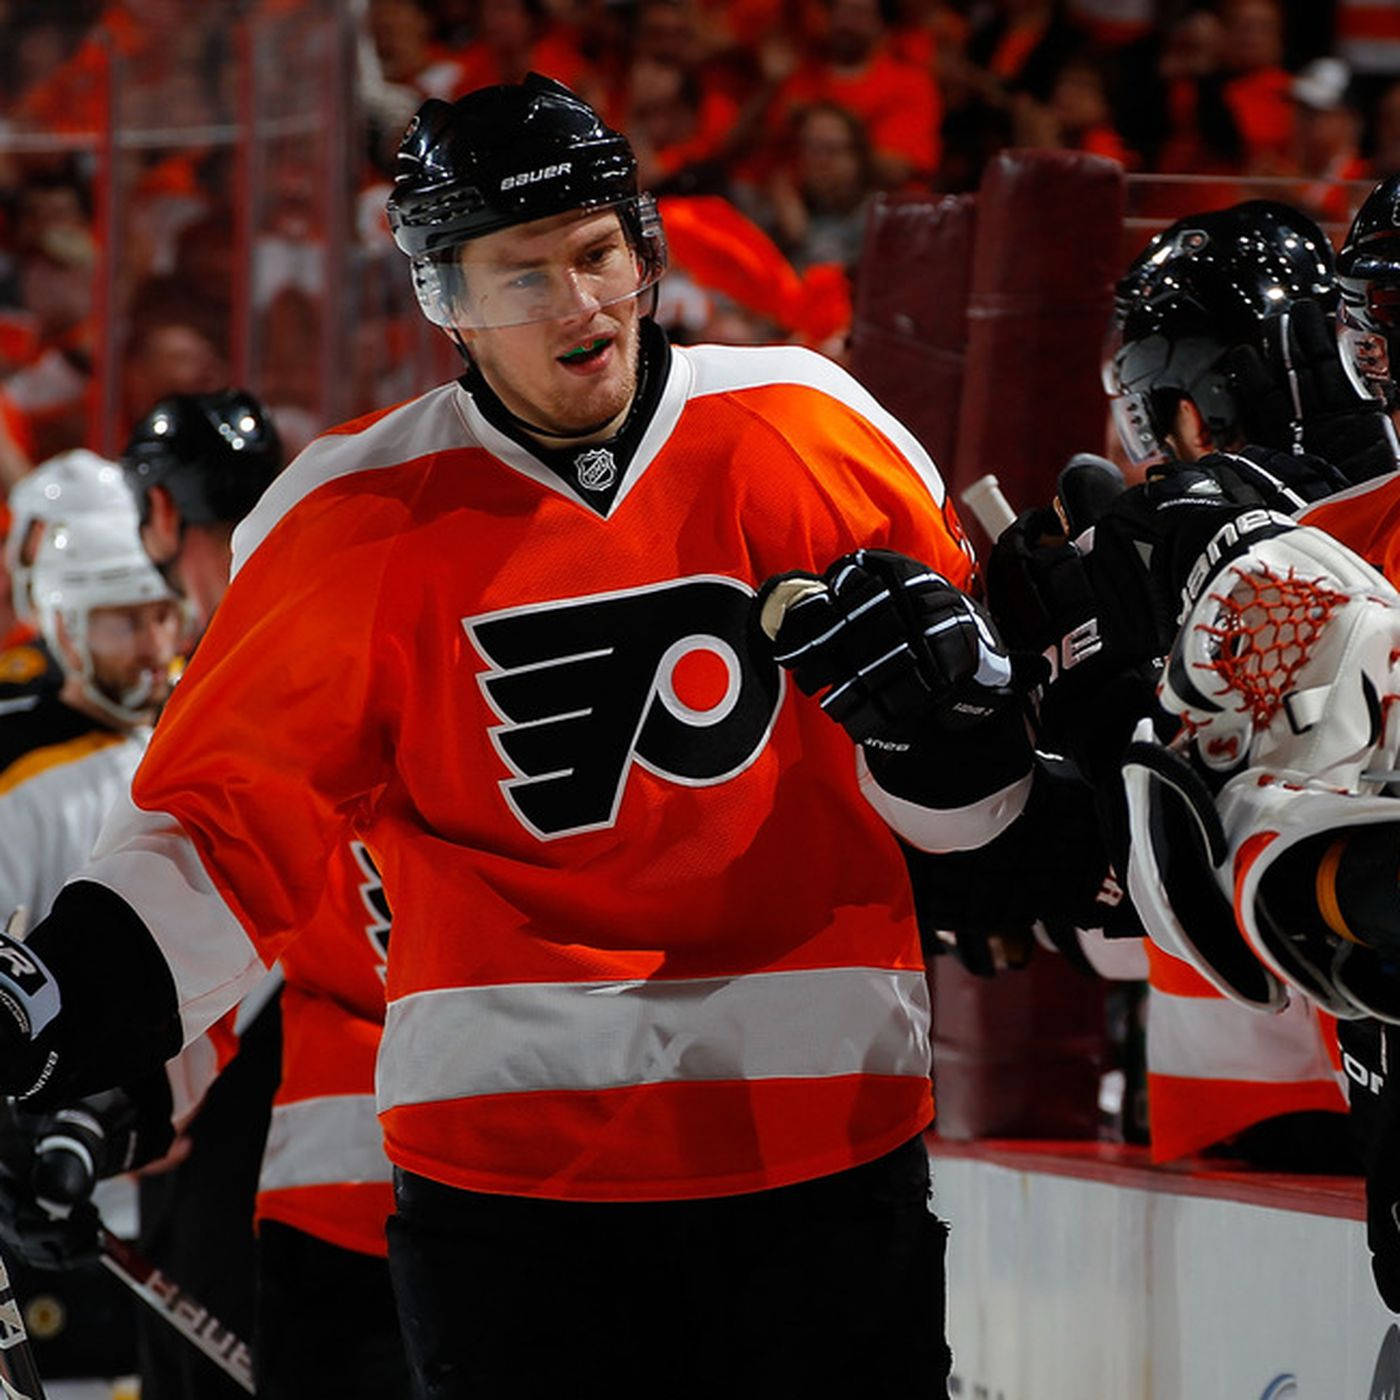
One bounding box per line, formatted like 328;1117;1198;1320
1103;199;1337;462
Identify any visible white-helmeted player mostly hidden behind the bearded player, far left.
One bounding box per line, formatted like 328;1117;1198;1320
0;448;132;714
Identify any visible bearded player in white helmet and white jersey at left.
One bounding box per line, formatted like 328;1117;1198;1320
0;512;181;1369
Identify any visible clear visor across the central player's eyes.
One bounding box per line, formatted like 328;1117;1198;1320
412;195;666;330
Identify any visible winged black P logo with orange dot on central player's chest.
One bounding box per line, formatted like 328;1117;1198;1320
462;575;783;840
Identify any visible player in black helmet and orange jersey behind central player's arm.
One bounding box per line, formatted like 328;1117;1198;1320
122;389;407;1400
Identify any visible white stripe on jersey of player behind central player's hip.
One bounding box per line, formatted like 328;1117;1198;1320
258;1093;393;1191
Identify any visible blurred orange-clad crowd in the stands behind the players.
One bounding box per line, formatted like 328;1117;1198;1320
0;0;1400;483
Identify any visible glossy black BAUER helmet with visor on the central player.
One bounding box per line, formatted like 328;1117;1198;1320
388;73;666;328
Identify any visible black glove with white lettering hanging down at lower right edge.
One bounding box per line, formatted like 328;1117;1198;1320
1337;1021;1400;1313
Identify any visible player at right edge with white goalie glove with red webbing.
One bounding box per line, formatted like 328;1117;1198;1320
991;182;1400;1309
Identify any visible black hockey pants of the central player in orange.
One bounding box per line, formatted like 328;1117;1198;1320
389;1138;951;1400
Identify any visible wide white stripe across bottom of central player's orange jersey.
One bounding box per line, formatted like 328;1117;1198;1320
378;967;930;1112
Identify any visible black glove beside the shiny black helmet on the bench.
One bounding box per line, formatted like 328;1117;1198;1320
1226;301;1397;484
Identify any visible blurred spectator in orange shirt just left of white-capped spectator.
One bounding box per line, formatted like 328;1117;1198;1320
1221;0;1295;174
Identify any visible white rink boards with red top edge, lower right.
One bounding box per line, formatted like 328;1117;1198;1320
931;1141;1400;1400
